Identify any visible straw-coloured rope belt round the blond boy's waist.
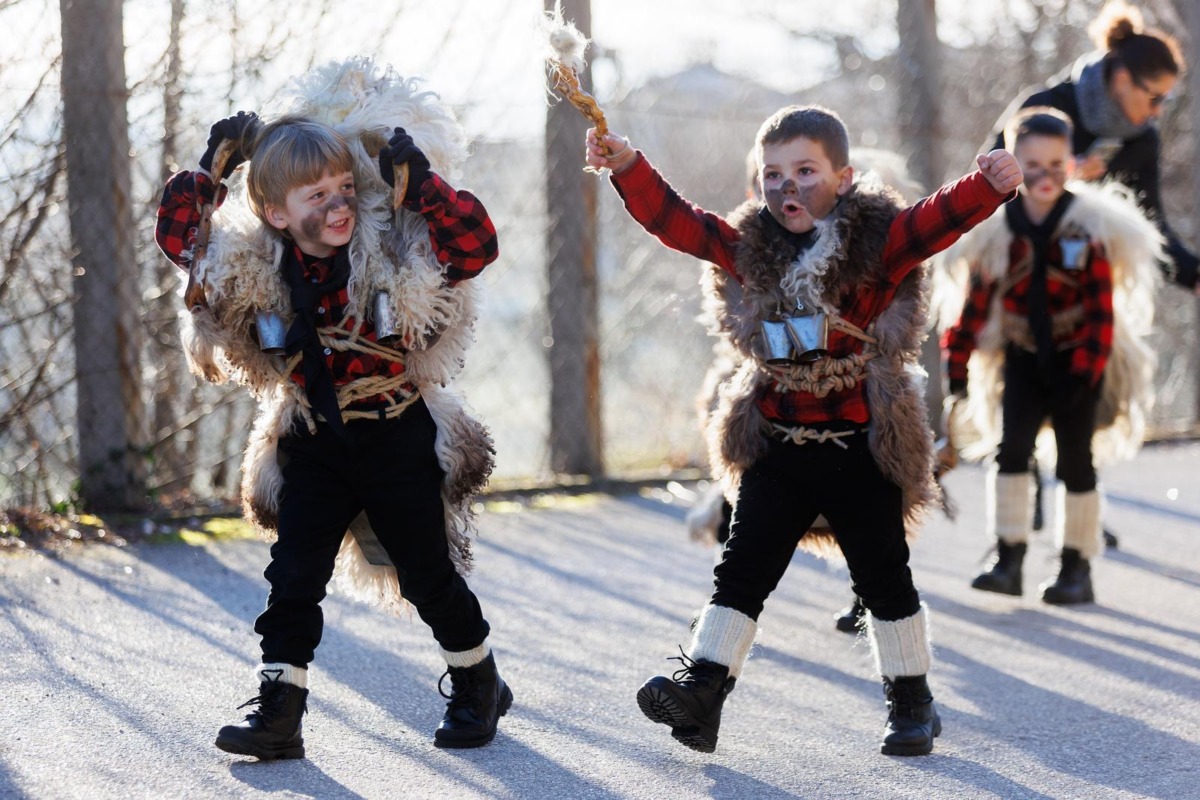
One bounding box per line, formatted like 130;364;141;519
287;323;421;433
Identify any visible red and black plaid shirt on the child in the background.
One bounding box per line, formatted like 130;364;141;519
942;231;1112;386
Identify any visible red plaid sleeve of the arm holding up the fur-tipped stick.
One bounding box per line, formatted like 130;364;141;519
612;152;739;277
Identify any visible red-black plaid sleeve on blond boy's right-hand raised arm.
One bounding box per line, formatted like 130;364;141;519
404;173;499;283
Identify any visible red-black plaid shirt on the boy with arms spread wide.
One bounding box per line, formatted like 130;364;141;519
612;154;1007;425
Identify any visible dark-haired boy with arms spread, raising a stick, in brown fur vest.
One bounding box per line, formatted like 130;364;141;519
587;107;1020;756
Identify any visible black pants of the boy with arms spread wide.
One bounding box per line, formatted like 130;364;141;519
710;425;920;620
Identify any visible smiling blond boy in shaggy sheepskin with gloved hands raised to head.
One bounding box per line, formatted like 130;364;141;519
157;60;512;759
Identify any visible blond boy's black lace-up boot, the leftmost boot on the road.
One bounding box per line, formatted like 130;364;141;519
216;679;308;760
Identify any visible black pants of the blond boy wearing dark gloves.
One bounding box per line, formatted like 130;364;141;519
254;401;488;667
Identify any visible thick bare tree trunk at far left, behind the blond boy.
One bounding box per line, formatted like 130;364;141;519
59;0;145;511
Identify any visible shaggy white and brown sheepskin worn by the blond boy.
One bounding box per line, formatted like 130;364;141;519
181;59;494;610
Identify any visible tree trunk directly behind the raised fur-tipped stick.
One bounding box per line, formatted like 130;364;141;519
546;0;604;477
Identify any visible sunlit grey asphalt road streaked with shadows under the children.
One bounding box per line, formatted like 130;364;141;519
0;444;1200;800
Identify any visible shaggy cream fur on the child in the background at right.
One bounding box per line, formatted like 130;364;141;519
934;182;1163;464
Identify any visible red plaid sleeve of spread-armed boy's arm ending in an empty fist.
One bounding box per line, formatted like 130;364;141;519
883;172;1016;283
